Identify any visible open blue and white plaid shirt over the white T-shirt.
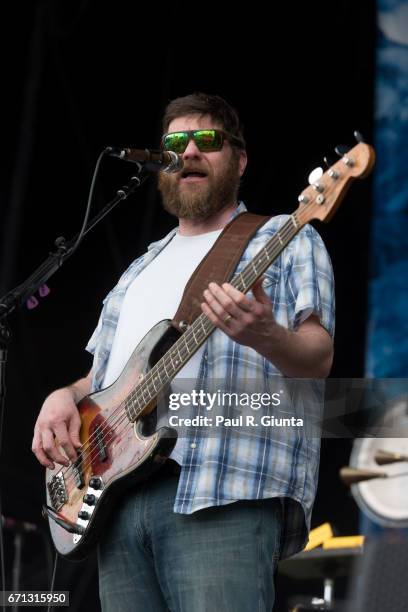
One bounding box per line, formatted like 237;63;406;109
86;202;334;557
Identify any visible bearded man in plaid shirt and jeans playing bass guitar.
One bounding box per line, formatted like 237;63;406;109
33;94;334;612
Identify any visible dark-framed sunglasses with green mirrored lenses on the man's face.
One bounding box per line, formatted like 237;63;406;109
161;130;244;153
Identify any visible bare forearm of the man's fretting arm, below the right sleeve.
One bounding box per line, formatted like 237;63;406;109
252;322;333;378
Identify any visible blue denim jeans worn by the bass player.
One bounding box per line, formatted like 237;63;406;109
98;476;282;612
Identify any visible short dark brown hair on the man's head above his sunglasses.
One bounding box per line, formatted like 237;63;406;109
163;92;245;149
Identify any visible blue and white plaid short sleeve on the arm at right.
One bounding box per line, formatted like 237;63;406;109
286;225;335;337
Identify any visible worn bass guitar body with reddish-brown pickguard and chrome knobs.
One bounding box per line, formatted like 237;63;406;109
46;321;180;560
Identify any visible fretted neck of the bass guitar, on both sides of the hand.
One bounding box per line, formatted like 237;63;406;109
125;211;307;422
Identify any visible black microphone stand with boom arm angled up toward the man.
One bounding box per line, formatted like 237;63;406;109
0;163;149;590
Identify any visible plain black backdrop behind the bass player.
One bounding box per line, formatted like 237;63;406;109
0;0;375;608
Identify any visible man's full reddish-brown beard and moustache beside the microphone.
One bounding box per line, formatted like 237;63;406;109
158;155;239;220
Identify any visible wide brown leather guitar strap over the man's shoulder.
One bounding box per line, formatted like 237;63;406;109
172;212;270;331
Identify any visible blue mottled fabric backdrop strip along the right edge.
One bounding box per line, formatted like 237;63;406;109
366;0;408;378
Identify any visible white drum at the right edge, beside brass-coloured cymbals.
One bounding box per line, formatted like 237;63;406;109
350;397;408;528
